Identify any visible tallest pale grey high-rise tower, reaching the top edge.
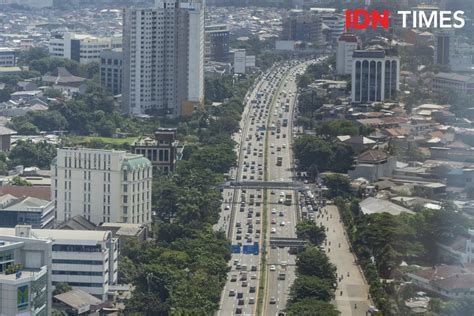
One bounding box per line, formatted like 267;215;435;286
122;0;204;117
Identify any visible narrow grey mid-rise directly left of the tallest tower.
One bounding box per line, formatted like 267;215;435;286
100;49;123;95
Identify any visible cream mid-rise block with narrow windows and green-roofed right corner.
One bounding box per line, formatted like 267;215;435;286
51;148;152;225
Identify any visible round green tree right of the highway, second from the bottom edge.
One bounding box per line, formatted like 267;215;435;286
290;275;334;302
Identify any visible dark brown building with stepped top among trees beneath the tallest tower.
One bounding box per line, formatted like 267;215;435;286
131;128;183;173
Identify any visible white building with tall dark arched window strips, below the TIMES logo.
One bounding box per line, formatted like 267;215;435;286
351;50;400;103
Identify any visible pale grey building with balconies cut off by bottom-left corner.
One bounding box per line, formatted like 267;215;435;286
0;226;52;316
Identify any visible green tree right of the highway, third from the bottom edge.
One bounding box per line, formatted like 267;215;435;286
296;246;336;283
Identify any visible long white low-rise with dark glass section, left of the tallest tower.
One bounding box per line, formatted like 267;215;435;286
48;33;122;64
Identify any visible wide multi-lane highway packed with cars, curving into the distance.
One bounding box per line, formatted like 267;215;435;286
215;61;314;315
